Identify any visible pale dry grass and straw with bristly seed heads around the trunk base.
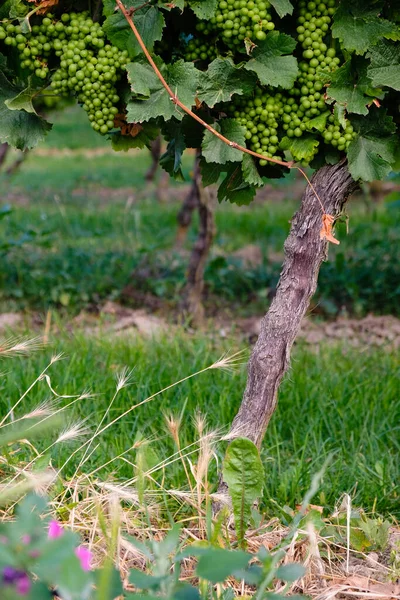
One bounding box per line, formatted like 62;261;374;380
0;340;400;600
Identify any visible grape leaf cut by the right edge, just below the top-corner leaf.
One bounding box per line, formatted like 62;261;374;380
367;40;400;91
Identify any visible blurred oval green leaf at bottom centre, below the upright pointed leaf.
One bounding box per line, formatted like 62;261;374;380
196;548;252;583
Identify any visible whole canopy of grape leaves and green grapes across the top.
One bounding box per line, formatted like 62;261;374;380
0;0;400;193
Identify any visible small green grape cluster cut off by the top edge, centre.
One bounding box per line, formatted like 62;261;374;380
210;0;275;51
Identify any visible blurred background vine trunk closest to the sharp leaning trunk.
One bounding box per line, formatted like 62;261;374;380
184;161;215;327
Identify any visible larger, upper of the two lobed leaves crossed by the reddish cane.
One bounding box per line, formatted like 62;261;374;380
127;60;200;123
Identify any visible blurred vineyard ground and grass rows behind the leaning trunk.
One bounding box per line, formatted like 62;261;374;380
0;109;400;516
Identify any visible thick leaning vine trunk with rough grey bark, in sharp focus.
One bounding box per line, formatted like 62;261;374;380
231;162;356;447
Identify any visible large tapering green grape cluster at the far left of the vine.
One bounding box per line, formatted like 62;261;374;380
0;12;128;134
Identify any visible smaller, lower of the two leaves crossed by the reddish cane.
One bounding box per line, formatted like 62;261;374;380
202;119;246;165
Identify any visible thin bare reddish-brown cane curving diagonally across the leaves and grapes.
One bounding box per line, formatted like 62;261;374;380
115;0;326;215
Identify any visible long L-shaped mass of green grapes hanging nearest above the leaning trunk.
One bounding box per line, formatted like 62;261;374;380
226;0;355;165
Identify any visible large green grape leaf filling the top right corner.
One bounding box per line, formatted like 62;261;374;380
332;0;397;54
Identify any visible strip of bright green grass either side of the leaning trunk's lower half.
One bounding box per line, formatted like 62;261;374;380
0;332;400;516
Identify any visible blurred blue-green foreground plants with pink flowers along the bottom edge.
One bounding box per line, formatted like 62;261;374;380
0;495;305;600
